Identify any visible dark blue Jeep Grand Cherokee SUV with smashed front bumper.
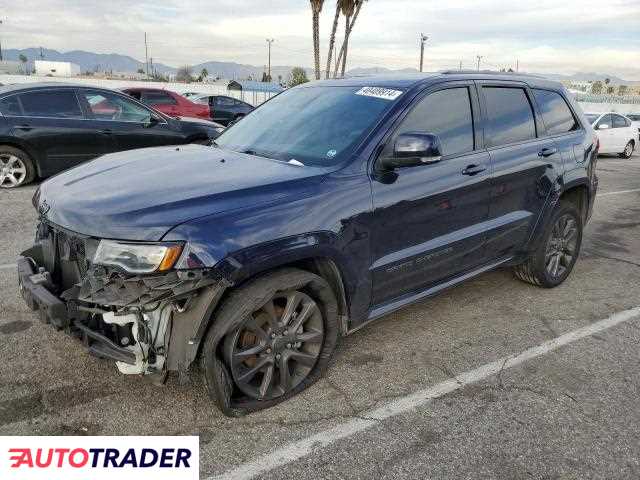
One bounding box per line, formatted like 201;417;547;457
18;72;598;415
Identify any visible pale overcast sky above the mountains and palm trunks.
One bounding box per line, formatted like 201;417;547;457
0;0;640;80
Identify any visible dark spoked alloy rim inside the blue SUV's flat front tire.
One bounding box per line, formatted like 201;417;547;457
225;290;325;400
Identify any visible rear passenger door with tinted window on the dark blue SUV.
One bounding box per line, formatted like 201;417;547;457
478;81;562;258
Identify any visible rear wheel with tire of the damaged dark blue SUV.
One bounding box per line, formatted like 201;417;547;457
514;201;583;288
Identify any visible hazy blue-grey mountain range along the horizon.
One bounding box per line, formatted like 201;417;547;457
3;48;640;85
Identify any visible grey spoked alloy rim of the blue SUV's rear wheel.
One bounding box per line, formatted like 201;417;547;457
544;214;578;278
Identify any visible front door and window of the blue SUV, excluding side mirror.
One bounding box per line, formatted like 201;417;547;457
371;82;490;306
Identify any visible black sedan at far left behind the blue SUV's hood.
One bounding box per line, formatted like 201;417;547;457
0;83;224;188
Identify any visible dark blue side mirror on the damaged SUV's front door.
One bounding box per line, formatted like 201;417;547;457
382;133;442;170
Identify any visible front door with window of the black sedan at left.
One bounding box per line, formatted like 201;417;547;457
79;89;185;151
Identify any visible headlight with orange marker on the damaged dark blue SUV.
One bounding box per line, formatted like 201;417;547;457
93;240;182;273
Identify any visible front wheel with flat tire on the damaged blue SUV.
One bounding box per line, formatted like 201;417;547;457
201;268;339;416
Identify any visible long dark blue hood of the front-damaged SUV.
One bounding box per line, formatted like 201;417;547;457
36;145;325;241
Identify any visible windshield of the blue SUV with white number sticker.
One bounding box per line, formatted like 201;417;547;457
216;87;402;166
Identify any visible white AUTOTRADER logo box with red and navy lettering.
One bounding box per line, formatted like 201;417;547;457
0;437;199;480
